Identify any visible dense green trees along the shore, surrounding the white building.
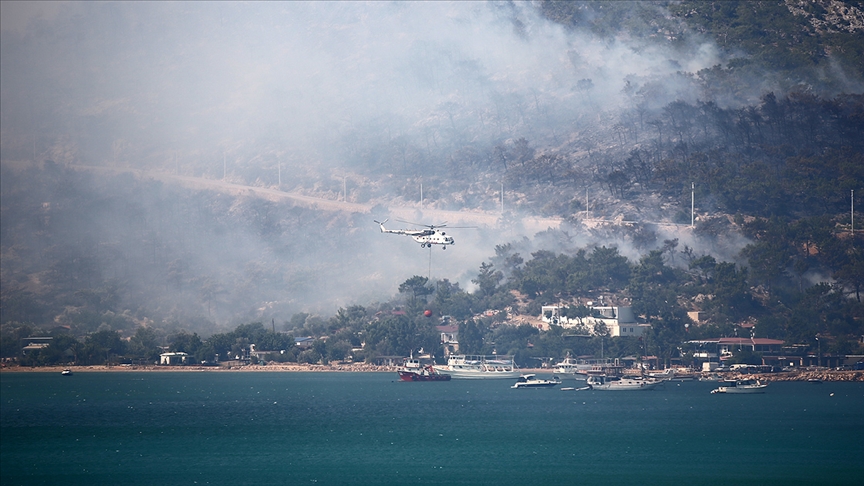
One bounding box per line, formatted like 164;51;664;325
8;221;864;365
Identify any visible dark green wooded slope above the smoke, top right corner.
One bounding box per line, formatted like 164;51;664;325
540;1;864;84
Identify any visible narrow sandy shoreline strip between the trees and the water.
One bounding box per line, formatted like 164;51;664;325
0;363;864;382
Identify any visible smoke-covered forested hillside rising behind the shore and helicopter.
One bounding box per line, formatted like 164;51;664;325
0;0;864;363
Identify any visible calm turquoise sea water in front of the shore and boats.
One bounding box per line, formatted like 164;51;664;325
0;372;864;486
